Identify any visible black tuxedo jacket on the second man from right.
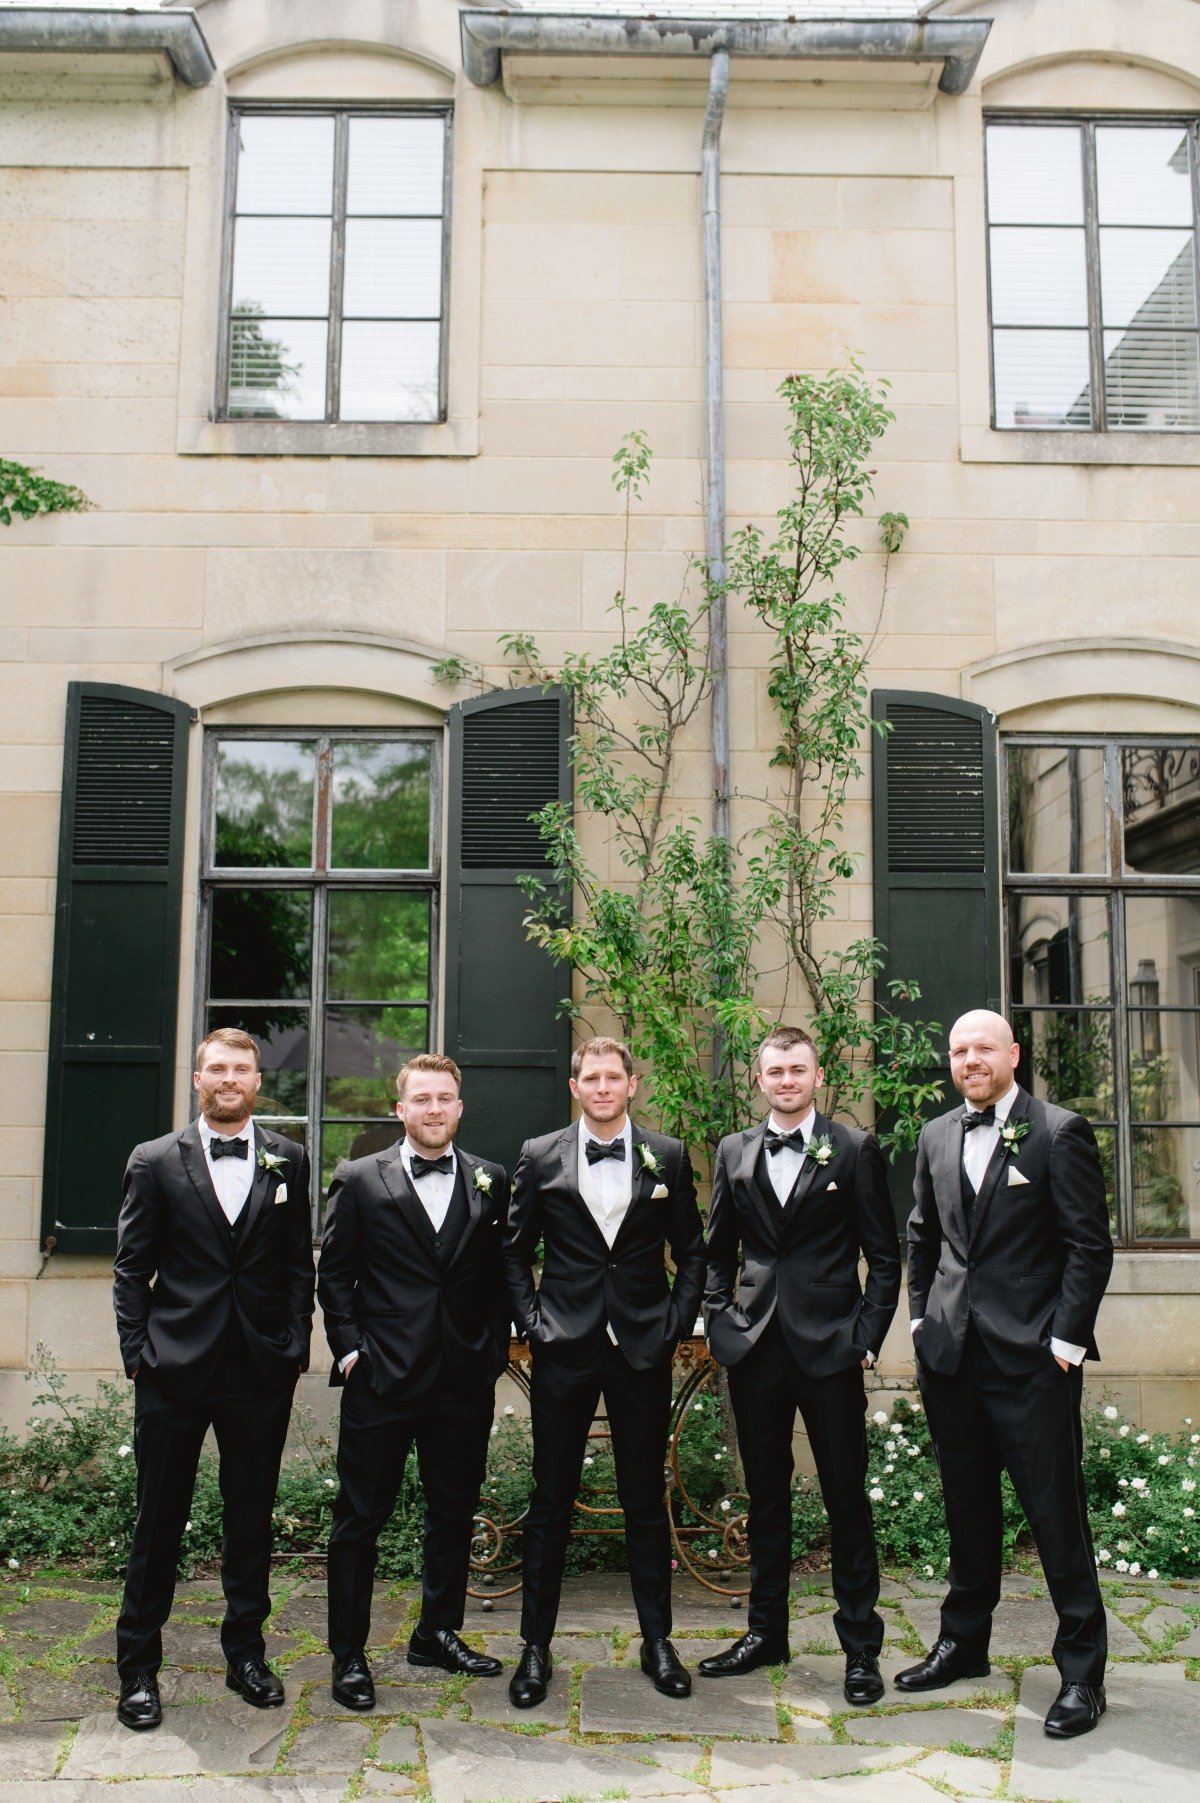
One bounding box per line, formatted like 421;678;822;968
705;1114;901;1377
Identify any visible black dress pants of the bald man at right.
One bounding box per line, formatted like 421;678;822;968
917;1323;1108;1684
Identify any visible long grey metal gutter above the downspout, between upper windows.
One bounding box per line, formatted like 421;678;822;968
459;11;991;94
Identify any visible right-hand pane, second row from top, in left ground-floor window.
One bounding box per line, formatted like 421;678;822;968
328;889;429;1002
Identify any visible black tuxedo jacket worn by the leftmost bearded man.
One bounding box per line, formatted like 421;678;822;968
114;1121;314;1399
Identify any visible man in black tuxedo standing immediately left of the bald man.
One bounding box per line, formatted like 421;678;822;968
699;1028;901;1704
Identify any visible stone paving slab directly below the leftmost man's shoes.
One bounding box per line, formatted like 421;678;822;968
63;1704;288;1796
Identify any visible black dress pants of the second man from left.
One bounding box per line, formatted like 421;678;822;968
328;1359;495;1659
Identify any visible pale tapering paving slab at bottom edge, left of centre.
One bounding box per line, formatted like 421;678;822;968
423;1722;706;1803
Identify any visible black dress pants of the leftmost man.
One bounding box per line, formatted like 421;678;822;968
117;1356;295;1677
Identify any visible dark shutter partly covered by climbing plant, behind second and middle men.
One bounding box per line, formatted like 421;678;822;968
443;689;571;1174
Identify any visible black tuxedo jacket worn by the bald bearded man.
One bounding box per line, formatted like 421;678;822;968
908;1089;1112;1377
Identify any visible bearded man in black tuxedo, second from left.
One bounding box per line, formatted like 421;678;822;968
317;1053;512;1709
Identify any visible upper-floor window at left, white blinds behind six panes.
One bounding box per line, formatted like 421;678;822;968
218;106;450;424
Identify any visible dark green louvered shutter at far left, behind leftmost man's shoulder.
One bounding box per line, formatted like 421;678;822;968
41;683;187;1253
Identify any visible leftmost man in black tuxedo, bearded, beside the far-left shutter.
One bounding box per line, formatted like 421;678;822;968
114;1028;314;1727
